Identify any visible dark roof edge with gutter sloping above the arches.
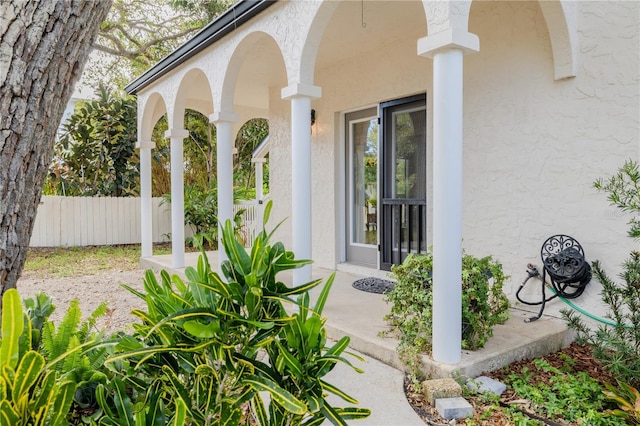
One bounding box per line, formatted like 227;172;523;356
124;0;277;95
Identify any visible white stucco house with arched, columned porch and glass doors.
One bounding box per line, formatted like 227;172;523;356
127;0;640;363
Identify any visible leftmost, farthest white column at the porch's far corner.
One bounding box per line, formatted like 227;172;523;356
137;141;156;257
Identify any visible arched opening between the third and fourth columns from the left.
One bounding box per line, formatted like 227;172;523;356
220;31;291;245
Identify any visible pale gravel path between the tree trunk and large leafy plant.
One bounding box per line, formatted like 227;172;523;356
17;269;146;334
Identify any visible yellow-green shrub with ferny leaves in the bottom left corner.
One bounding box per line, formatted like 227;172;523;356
0;289;104;426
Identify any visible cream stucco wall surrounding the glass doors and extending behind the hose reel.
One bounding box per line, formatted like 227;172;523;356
313;2;640;320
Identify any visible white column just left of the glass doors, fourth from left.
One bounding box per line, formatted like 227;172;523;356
282;84;321;285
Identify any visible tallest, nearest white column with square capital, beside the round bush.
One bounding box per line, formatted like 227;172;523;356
418;31;479;364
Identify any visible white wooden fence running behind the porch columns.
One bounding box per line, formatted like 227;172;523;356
29;195;262;247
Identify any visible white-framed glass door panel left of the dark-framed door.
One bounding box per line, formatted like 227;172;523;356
345;107;378;268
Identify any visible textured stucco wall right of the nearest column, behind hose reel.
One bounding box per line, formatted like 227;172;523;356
464;2;640;312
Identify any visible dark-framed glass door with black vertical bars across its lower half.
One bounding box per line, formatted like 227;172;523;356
380;95;427;270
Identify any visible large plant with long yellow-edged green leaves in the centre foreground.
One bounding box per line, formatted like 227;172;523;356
104;204;369;426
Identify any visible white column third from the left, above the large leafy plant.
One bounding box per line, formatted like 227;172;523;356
209;111;238;268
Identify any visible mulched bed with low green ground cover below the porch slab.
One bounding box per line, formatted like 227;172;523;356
405;343;635;426
